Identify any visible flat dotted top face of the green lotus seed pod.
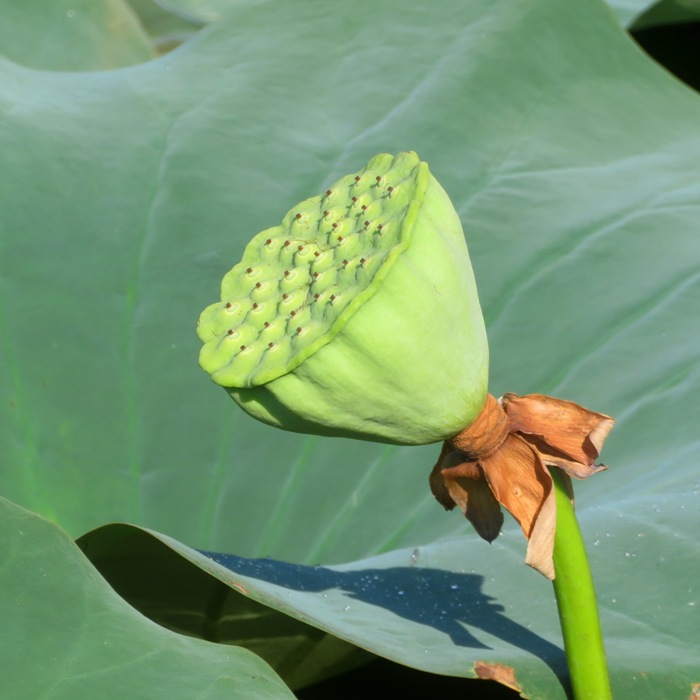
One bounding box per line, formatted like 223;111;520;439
198;152;430;388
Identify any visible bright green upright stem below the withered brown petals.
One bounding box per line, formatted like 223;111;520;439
552;469;612;700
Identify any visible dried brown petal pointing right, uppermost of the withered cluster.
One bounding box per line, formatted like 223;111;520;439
501;393;615;468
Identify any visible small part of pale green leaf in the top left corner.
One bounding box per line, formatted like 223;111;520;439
0;0;152;71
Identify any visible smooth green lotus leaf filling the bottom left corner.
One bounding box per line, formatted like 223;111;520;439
0;498;294;700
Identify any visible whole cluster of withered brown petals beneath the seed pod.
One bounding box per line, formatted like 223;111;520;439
430;394;615;579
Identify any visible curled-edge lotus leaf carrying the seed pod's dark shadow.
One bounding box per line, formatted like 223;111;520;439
79;523;698;700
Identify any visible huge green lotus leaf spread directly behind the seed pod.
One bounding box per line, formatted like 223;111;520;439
0;0;700;697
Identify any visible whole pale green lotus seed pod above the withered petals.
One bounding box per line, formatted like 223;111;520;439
198;152;488;445
